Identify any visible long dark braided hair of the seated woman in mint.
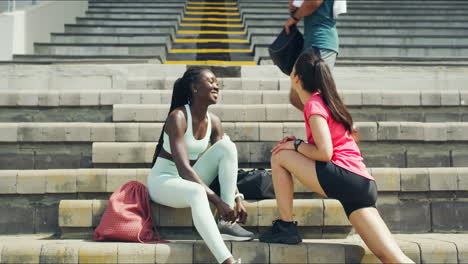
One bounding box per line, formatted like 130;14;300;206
151;68;210;167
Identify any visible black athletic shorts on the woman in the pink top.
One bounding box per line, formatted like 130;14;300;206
315;161;377;218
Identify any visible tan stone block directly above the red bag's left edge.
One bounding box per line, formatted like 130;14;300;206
76;169;107;192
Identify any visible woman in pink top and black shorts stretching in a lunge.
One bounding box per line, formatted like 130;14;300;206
260;53;412;263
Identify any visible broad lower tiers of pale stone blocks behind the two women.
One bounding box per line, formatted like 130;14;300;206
0;64;468;263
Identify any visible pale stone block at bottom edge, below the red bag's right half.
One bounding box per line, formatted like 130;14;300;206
117;243;156;264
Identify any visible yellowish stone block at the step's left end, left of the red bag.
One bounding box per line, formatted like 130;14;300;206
59;200;93;227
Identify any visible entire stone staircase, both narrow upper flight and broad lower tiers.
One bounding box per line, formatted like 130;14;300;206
0;0;468;263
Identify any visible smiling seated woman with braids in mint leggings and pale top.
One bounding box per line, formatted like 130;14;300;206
148;68;254;263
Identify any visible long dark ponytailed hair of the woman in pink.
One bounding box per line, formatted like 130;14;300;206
295;53;359;141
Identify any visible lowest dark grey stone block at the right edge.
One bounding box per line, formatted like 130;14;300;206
432;201;468;233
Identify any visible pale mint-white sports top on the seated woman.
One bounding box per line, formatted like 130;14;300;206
163;104;211;160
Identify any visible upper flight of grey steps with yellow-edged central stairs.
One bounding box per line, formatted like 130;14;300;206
4;0;468;66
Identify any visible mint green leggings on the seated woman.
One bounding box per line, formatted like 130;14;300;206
148;136;238;263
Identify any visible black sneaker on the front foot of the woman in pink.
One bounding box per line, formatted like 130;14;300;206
259;219;302;244
